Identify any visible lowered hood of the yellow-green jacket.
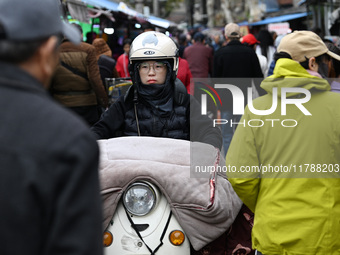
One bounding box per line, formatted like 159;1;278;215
261;58;331;97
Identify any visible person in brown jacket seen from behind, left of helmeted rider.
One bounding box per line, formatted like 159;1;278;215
51;26;108;126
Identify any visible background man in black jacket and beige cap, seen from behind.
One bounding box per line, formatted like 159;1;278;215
213;23;264;154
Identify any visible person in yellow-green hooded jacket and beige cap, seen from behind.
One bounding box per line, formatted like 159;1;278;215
226;31;340;255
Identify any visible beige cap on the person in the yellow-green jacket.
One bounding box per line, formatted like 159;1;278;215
277;31;340;63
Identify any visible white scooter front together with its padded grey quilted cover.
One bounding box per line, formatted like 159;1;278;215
98;137;242;255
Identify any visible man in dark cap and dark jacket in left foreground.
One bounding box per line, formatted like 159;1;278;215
0;0;102;255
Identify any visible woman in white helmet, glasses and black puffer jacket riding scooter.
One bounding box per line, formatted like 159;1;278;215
91;31;222;149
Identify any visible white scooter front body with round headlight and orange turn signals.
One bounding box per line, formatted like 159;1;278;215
104;181;190;255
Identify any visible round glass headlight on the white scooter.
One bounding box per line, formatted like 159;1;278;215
123;182;156;216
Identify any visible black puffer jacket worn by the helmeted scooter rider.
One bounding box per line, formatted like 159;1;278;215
91;79;222;149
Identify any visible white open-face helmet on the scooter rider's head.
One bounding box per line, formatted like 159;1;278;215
129;31;179;78
